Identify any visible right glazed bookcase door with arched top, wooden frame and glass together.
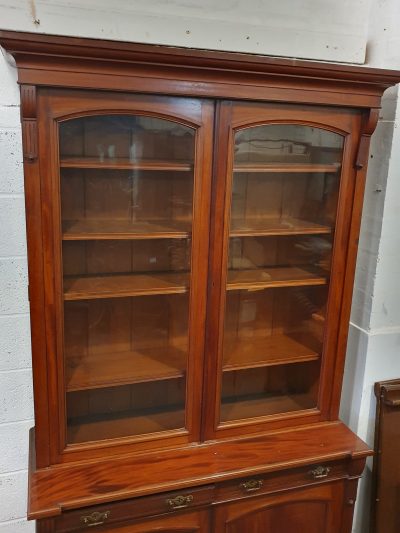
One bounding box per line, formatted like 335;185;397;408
205;103;364;433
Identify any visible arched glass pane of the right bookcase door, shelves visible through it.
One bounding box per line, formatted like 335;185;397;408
220;124;343;422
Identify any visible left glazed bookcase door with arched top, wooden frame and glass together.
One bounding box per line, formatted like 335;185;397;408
37;88;212;462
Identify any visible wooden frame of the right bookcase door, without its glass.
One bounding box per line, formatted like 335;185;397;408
203;101;364;440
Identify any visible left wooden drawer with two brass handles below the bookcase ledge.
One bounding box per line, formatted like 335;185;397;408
55;485;214;533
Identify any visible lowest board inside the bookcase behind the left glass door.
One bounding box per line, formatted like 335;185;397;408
67;409;185;444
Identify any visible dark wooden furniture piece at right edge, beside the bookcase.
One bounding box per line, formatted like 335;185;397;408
371;379;400;533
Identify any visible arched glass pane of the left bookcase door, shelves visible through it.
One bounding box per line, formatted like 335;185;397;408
60;115;195;444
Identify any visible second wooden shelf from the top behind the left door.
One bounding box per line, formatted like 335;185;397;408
63;219;191;241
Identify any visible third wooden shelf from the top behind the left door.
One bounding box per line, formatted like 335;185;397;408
64;272;189;300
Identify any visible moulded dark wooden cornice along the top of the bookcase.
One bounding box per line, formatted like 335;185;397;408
0;30;400;91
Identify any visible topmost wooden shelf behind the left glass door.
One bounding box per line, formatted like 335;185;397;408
60;157;193;172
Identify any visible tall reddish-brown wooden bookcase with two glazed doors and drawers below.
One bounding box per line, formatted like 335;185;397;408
0;32;400;533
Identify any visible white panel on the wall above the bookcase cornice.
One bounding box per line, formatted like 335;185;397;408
0;0;370;63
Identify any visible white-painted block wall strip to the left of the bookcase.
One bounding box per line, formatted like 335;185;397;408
0;55;34;533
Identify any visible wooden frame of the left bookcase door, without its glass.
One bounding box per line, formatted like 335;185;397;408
34;89;214;466
